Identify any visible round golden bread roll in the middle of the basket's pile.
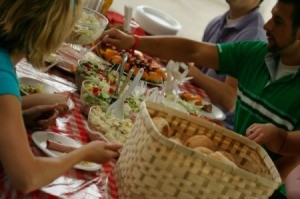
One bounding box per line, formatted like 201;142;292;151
184;135;214;151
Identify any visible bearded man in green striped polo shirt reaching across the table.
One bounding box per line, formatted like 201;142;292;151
100;0;300;196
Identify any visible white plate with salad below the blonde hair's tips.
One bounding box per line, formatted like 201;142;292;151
19;77;61;95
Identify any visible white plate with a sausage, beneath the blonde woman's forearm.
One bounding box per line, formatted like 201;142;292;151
32;131;102;171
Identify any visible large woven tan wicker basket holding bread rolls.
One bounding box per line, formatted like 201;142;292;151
115;103;281;199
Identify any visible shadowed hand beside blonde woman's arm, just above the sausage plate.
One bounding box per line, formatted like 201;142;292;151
23;105;59;130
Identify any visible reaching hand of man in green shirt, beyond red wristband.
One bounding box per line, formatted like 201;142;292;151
98;28;134;50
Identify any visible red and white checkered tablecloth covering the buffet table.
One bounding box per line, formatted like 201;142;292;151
0;51;207;198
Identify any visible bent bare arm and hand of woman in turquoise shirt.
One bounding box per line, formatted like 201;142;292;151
0;95;120;193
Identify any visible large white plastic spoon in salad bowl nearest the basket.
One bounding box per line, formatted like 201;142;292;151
106;68;144;119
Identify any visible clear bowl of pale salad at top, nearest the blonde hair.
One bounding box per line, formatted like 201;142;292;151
66;8;108;45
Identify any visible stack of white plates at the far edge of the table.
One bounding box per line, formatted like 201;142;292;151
134;5;181;35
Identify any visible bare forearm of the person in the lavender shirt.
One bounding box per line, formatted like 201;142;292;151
189;65;238;111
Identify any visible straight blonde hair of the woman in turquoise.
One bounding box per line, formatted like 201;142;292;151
0;0;83;68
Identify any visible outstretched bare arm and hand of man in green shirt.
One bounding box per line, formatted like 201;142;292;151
99;29;219;69
